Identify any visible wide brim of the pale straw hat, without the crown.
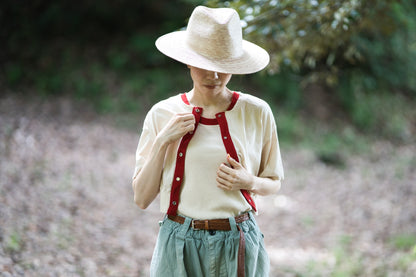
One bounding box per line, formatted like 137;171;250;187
156;31;270;74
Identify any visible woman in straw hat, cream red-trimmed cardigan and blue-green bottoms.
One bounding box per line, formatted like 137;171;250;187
133;6;283;277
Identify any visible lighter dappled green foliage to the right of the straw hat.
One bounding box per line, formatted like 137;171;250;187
207;0;416;135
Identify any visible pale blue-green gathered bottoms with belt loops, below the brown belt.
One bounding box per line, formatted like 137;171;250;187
150;210;270;277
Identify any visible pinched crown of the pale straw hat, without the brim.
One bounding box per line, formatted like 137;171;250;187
186;6;243;60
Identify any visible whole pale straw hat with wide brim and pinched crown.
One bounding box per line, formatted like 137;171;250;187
156;6;270;74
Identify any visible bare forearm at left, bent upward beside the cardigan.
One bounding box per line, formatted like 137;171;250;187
132;138;168;209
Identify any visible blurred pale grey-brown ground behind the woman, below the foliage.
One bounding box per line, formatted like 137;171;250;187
0;95;416;277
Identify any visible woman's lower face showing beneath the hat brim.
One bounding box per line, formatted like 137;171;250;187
188;65;232;94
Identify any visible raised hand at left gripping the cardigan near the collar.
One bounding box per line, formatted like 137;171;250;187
157;113;195;144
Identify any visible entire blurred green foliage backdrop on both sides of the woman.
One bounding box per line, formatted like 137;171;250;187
0;0;416;141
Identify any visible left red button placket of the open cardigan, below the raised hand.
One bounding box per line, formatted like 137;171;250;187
167;107;202;215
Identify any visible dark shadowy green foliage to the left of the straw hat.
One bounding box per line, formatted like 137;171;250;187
0;0;202;112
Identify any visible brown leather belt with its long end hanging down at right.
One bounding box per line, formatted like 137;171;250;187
168;213;250;277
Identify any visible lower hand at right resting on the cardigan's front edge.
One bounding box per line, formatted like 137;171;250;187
216;155;254;191
